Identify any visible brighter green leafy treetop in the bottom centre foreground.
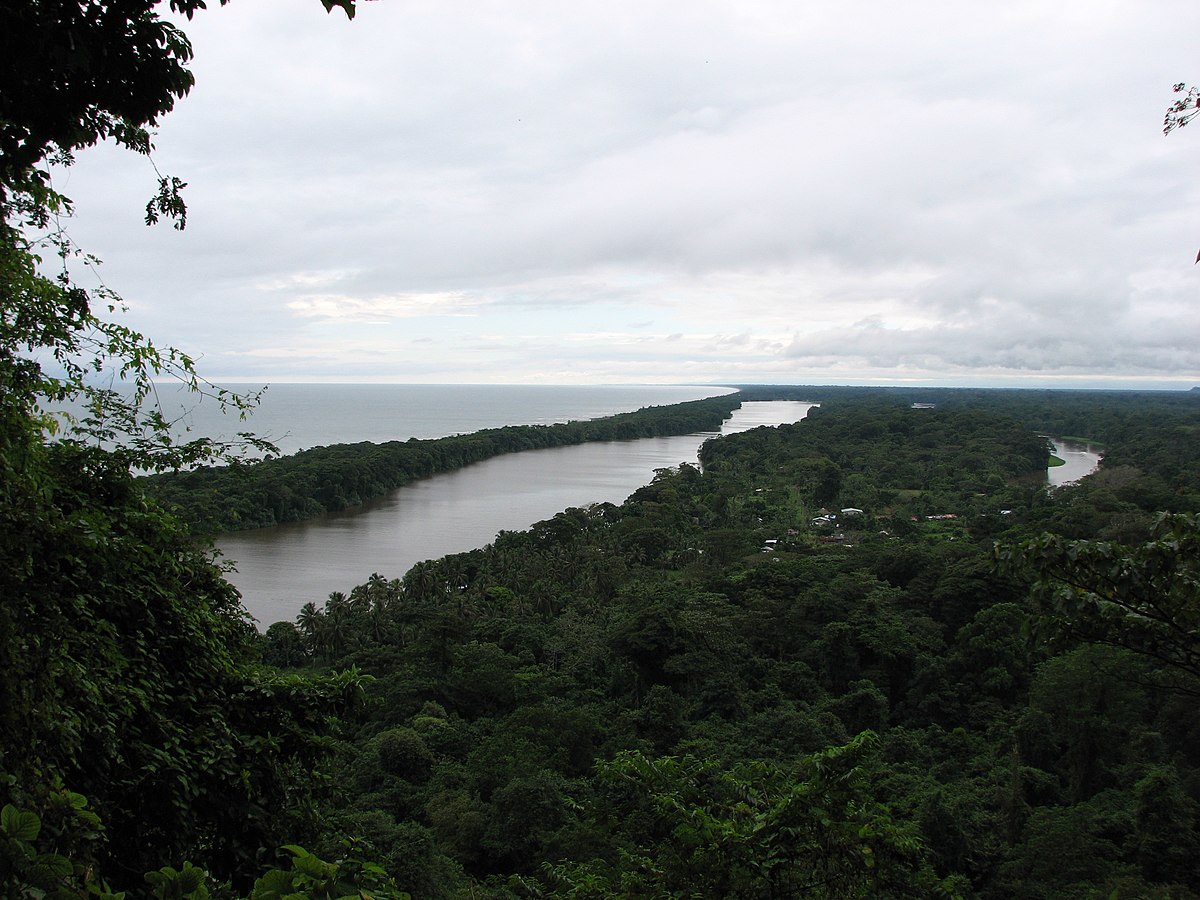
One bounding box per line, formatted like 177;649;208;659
535;732;948;898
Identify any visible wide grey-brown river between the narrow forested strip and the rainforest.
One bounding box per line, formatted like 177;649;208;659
217;395;812;626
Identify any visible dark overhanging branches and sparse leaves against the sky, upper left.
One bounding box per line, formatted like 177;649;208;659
0;0;354;468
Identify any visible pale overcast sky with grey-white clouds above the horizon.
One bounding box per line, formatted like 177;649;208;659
55;0;1200;389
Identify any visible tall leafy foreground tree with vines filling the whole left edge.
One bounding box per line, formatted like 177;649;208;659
0;0;364;883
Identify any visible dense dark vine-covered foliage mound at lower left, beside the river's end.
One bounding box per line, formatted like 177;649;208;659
0;412;374;875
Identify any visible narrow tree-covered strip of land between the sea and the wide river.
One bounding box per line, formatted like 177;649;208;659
144;394;742;533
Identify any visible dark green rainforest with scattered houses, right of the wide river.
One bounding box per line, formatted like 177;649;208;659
238;388;1200;898
